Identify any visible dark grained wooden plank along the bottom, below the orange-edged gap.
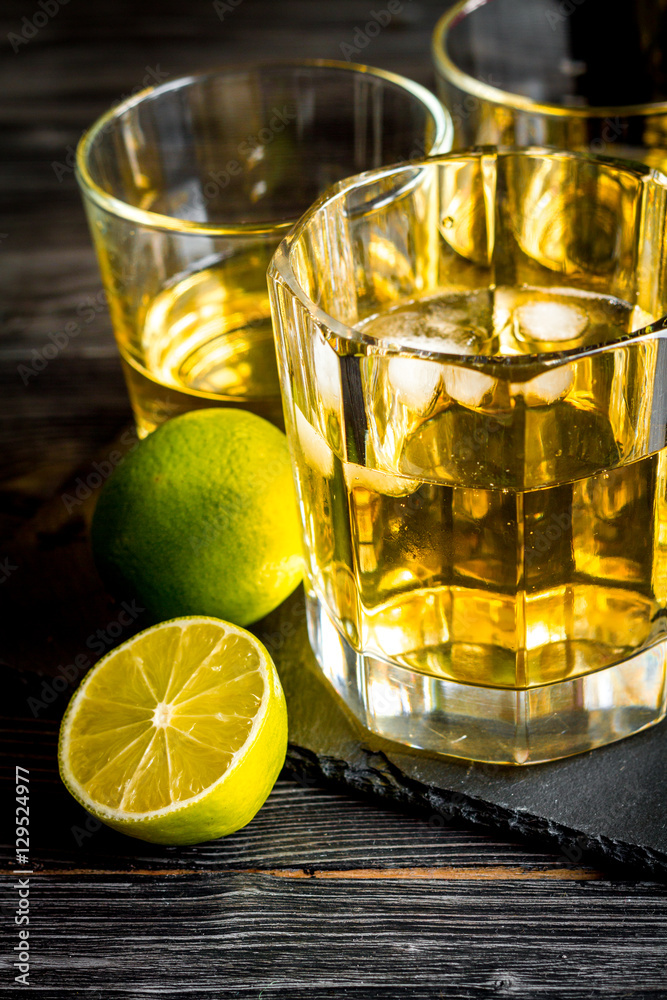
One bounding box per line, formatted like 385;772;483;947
1;873;667;1000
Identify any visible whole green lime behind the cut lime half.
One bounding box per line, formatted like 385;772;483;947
92;408;303;625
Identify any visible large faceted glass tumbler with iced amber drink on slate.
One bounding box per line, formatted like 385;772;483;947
269;147;667;764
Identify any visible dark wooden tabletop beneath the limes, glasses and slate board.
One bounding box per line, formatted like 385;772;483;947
0;0;667;1000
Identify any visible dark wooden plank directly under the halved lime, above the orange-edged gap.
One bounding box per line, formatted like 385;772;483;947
0;744;602;879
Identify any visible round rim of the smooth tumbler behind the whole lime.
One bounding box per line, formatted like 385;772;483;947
75;59;454;238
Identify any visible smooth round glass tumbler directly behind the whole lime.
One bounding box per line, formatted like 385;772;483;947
77;60;452;437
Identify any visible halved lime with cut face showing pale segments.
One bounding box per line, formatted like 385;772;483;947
58;617;287;844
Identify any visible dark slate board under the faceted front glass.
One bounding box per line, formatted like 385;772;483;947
255;589;667;876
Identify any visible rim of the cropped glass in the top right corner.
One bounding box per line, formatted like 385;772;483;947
431;0;667;119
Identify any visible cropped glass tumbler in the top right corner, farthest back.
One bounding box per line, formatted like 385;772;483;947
433;0;667;170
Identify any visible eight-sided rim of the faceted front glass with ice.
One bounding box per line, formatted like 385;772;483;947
267;146;667;377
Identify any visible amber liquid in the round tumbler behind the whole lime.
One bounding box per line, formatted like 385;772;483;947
118;252;283;437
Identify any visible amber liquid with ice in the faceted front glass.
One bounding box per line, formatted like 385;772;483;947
294;288;667;688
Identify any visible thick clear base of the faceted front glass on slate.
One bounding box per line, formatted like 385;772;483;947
306;595;667;764
